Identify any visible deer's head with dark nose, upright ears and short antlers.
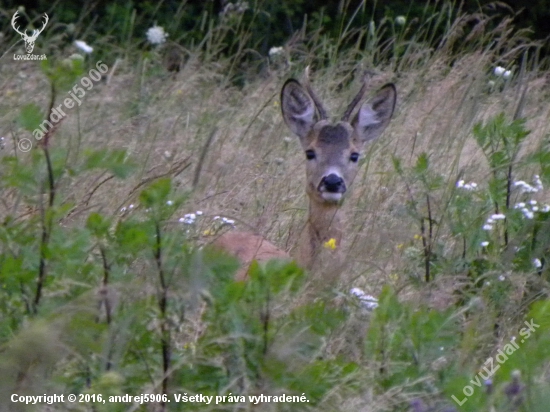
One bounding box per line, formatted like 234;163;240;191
281;69;396;206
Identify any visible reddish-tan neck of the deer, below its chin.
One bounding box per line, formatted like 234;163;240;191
299;199;342;269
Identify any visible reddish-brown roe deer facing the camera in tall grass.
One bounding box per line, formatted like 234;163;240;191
213;68;397;281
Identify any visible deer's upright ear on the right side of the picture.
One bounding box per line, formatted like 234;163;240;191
352;83;397;145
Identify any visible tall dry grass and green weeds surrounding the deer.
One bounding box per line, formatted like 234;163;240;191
0;2;550;412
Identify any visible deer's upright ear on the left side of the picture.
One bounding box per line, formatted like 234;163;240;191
281;79;317;145
